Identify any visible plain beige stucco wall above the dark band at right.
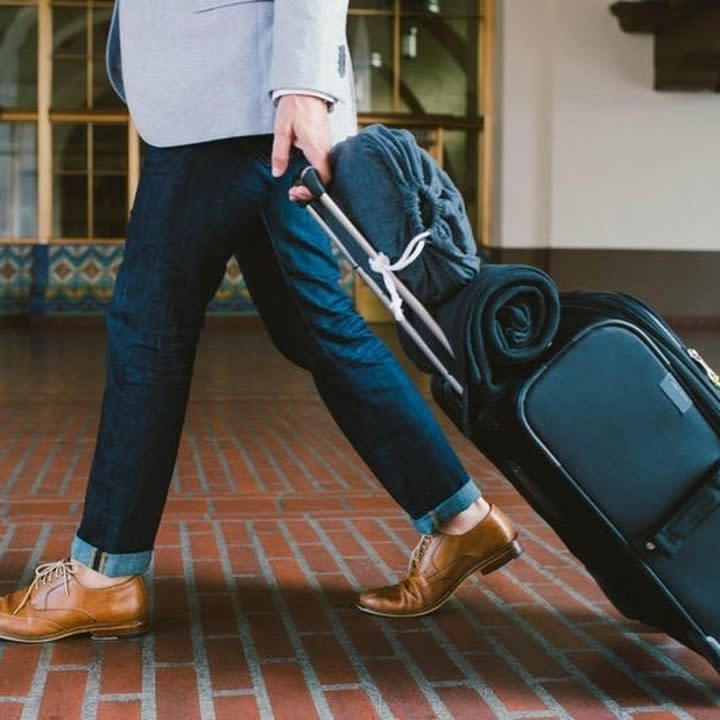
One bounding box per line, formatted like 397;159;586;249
495;0;720;250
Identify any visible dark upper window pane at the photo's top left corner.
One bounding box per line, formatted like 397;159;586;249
0;6;37;108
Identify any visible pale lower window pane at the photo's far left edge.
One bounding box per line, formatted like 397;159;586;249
0;123;37;238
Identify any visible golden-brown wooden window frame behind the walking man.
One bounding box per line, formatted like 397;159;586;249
0;0;496;246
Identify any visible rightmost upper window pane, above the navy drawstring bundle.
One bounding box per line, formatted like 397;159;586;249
400;16;478;116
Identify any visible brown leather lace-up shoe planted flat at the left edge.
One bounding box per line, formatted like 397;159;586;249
0;560;149;643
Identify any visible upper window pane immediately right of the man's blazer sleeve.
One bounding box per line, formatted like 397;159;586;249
348;15;396;112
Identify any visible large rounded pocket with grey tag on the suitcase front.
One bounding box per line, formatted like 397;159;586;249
517;321;720;547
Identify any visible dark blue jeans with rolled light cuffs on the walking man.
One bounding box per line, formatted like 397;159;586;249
72;136;479;575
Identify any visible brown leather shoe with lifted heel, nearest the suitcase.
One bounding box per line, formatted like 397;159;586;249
357;505;522;617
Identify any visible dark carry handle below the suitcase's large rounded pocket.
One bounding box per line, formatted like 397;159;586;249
644;463;720;557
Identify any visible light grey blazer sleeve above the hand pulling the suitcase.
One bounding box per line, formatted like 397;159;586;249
268;0;350;100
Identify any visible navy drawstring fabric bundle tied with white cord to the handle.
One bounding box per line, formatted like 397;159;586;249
328;124;482;304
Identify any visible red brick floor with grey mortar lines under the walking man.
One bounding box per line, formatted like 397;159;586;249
0;329;720;720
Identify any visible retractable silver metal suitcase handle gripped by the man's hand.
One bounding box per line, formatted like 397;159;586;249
295;166;464;396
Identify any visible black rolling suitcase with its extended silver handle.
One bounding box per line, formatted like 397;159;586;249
299;152;720;672
